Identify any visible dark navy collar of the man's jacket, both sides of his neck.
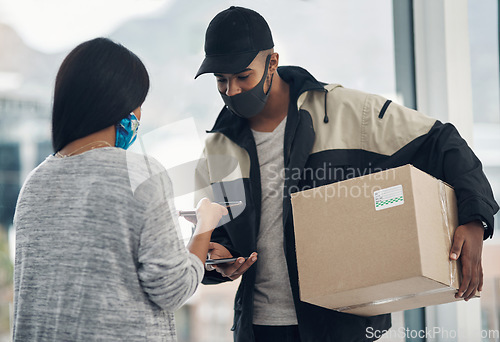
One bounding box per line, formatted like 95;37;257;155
207;66;326;146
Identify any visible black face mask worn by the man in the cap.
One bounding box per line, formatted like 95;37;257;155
220;55;274;119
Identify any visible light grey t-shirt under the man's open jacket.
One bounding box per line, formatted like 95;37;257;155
252;118;297;326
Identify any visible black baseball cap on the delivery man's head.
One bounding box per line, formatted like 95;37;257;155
195;6;274;78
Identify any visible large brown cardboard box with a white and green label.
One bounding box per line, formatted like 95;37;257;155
292;165;476;316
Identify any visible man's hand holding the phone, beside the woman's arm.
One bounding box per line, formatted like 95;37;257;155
205;242;257;280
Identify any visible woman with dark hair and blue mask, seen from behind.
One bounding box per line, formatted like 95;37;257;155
13;38;227;341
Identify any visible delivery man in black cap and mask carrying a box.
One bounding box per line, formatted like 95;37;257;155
196;7;498;342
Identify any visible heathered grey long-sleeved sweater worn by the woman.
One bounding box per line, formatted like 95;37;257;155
13;147;204;341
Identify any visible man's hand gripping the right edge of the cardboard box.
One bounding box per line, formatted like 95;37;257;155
450;221;484;301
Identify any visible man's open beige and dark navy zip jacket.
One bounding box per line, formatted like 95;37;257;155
197;67;498;342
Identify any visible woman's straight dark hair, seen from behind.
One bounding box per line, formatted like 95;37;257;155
52;38;149;152
